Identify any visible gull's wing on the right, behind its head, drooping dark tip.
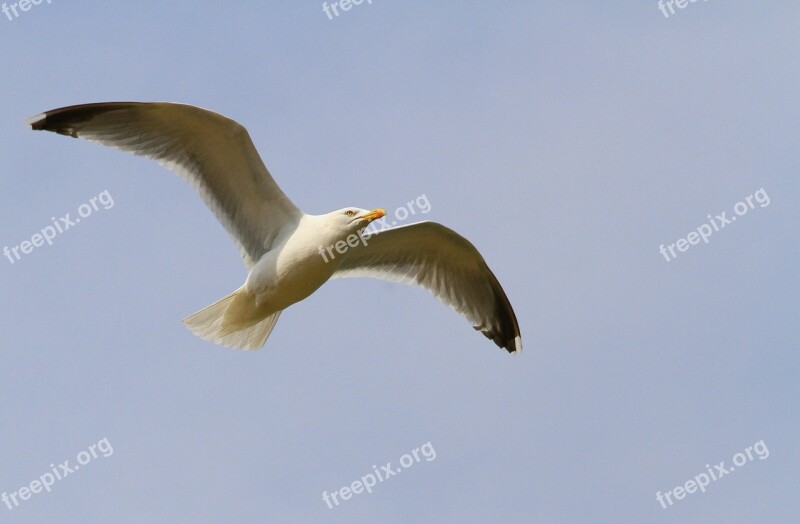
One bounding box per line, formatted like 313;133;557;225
333;222;522;353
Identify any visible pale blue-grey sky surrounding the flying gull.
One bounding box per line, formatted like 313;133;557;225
0;0;800;524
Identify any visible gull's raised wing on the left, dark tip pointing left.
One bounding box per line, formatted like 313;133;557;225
28;102;302;268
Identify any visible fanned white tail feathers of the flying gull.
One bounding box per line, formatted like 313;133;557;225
183;287;281;350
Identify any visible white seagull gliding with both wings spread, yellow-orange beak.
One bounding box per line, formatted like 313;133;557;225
27;102;522;353
